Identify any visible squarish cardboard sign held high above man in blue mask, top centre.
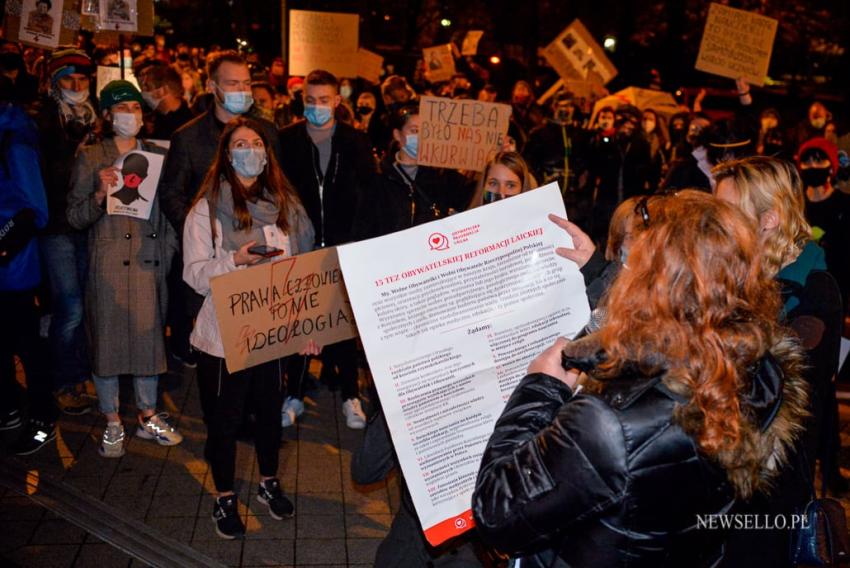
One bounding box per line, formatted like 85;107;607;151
289;10;360;77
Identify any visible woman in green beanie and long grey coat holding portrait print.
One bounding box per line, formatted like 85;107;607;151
67;81;183;458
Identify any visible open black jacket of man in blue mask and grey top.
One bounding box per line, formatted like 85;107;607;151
280;120;377;246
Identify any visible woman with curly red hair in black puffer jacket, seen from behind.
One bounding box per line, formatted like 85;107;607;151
472;191;807;567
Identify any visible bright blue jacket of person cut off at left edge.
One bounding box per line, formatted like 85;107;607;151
0;104;47;292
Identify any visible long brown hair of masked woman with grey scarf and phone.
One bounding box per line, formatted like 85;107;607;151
192;116;300;233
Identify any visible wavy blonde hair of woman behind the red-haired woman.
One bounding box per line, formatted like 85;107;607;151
712;156;812;276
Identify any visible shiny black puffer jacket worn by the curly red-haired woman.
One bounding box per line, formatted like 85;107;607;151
472;336;806;568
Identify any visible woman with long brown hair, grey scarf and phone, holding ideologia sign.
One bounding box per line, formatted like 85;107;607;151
183;117;320;539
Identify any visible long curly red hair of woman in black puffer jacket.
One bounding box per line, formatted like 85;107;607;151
599;191;780;462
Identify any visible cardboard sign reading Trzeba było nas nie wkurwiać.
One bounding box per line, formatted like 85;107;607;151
416;96;511;172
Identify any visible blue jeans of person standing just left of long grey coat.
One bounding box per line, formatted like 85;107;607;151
39;233;91;390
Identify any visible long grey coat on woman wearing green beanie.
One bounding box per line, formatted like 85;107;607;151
67;138;178;377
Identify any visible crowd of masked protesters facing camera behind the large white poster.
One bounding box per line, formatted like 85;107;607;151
0;32;850;568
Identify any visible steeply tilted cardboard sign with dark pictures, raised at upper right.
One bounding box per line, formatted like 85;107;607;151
543;19;617;85
